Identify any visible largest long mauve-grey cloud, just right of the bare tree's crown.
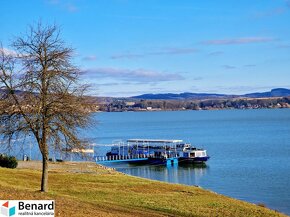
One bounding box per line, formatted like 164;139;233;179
83;68;184;82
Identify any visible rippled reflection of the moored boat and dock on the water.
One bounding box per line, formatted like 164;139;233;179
114;164;209;185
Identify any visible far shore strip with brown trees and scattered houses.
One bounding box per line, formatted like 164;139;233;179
97;96;290;112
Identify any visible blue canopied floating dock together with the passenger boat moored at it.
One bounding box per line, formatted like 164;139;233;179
95;139;209;165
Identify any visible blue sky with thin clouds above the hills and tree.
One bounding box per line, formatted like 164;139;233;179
0;0;290;96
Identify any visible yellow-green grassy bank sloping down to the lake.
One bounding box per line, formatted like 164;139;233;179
0;162;284;217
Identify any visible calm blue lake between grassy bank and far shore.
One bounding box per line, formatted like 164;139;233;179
2;109;290;215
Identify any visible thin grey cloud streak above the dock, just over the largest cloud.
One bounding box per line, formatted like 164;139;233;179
111;47;198;59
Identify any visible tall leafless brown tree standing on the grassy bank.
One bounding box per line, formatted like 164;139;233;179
0;23;91;192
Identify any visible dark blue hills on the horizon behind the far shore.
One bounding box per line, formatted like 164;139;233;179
131;88;290;100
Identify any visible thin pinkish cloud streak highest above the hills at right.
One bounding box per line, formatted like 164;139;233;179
202;37;275;45
